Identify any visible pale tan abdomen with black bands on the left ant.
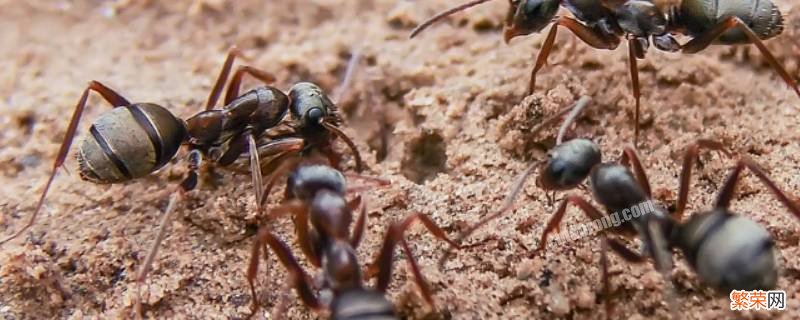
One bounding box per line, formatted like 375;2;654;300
77;103;186;183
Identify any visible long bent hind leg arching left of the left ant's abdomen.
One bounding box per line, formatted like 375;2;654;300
0;80;131;246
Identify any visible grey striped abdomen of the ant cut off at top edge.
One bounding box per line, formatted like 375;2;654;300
680;0;783;44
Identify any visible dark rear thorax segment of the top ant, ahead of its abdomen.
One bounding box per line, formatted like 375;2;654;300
612;0;667;37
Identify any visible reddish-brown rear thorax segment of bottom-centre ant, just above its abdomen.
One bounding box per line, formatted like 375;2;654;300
322;240;361;291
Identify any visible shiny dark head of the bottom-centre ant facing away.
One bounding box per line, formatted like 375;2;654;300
287;165;345;201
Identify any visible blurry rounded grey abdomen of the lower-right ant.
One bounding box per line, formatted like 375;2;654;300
676;209;778;293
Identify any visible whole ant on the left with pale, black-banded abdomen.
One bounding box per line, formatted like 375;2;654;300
0;47;362;315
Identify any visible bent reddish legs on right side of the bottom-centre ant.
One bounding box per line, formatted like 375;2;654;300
373;212;460;306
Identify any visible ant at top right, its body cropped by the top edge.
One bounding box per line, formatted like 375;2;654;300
410;0;800;145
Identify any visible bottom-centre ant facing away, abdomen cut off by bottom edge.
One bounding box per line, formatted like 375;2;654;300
247;163;458;319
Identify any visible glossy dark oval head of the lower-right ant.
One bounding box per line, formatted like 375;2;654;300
538;139;601;190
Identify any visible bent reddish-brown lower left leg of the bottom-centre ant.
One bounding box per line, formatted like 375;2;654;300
247;226;323;314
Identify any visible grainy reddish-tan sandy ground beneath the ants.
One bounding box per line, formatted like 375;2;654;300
0;0;800;319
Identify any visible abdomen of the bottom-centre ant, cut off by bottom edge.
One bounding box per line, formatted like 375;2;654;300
331;288;397;320
